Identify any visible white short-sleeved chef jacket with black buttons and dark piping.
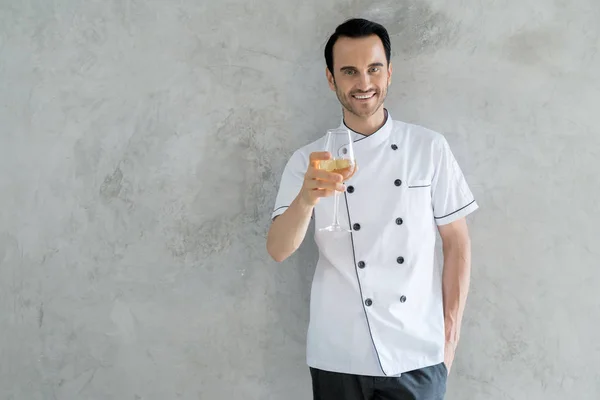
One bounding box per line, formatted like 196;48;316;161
272;113;478;376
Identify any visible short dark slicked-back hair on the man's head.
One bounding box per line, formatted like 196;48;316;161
325;18;392;74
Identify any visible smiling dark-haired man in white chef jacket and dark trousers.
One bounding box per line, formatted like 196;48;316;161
267;19;478;400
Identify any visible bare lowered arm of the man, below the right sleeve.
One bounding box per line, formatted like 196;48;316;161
438;217;471;371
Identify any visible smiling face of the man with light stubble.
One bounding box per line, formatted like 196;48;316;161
327;35;392;118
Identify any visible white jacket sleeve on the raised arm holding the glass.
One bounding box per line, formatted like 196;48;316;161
271;151;308;220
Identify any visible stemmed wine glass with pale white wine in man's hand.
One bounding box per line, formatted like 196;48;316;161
319;128;356;232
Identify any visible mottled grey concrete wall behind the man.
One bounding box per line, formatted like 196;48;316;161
0;0;600;400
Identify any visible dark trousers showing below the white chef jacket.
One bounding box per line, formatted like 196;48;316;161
310;363;448;400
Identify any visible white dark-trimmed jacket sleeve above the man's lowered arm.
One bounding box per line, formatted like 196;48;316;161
432;136;479;226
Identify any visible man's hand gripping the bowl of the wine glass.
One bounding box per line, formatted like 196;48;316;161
300;151;346;207
